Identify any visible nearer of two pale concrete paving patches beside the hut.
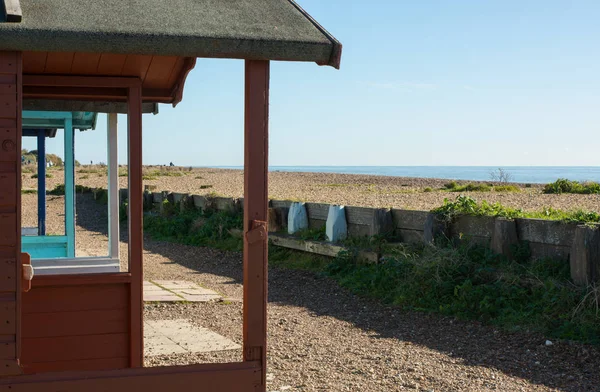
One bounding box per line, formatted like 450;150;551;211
144;320;241;356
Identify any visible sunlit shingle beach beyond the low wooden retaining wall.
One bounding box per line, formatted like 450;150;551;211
23;166;600;211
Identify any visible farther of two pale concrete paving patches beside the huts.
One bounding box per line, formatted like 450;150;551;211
144;280;222;302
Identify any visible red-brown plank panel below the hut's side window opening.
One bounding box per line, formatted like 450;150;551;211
20;283;130;373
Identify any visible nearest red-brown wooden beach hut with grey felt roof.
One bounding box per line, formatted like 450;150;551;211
0;0;341;392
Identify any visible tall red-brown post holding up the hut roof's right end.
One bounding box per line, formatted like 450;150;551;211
244;60;269;391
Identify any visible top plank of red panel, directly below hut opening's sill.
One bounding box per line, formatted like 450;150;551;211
23;284;129;314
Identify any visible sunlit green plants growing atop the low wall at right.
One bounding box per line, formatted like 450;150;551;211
431;195;600;223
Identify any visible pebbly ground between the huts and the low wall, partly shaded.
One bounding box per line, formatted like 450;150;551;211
18;195;600;392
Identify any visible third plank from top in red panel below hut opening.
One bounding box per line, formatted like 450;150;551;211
21;333;129;363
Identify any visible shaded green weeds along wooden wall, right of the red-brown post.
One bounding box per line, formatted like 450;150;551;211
269;245;600;344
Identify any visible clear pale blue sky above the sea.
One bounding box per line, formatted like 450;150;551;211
25;0;600;166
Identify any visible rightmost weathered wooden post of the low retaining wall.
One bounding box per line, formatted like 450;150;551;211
570;225;600;286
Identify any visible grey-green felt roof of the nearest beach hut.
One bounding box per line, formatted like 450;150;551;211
0;0;341;68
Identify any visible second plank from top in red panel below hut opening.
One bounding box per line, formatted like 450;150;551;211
22;308;129;338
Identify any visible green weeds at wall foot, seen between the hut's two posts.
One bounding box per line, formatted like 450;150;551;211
144;207;243;251
